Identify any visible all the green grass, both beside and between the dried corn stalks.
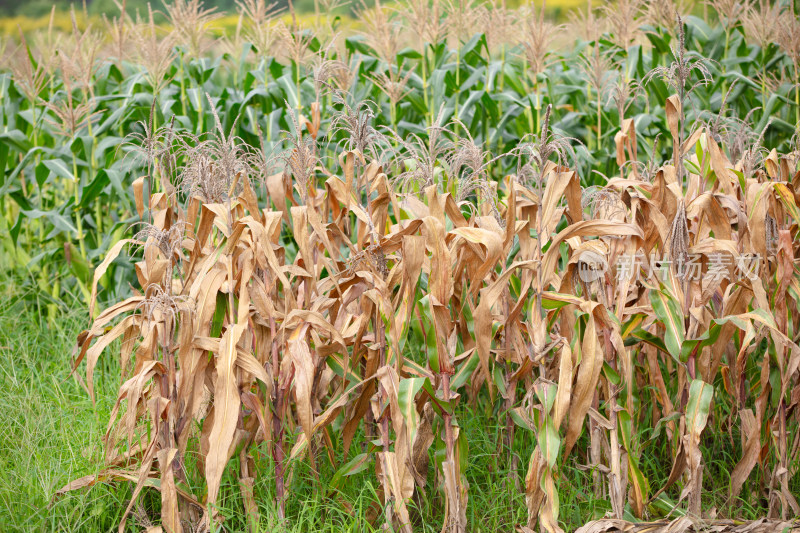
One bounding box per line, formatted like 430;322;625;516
0;276;780;533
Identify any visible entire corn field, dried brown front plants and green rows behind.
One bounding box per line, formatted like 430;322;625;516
0;0;800;533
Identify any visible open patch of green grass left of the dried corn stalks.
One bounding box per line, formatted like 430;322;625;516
0;280;126;531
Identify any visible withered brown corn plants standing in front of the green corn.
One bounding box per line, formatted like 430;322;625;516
63;81;800;532
